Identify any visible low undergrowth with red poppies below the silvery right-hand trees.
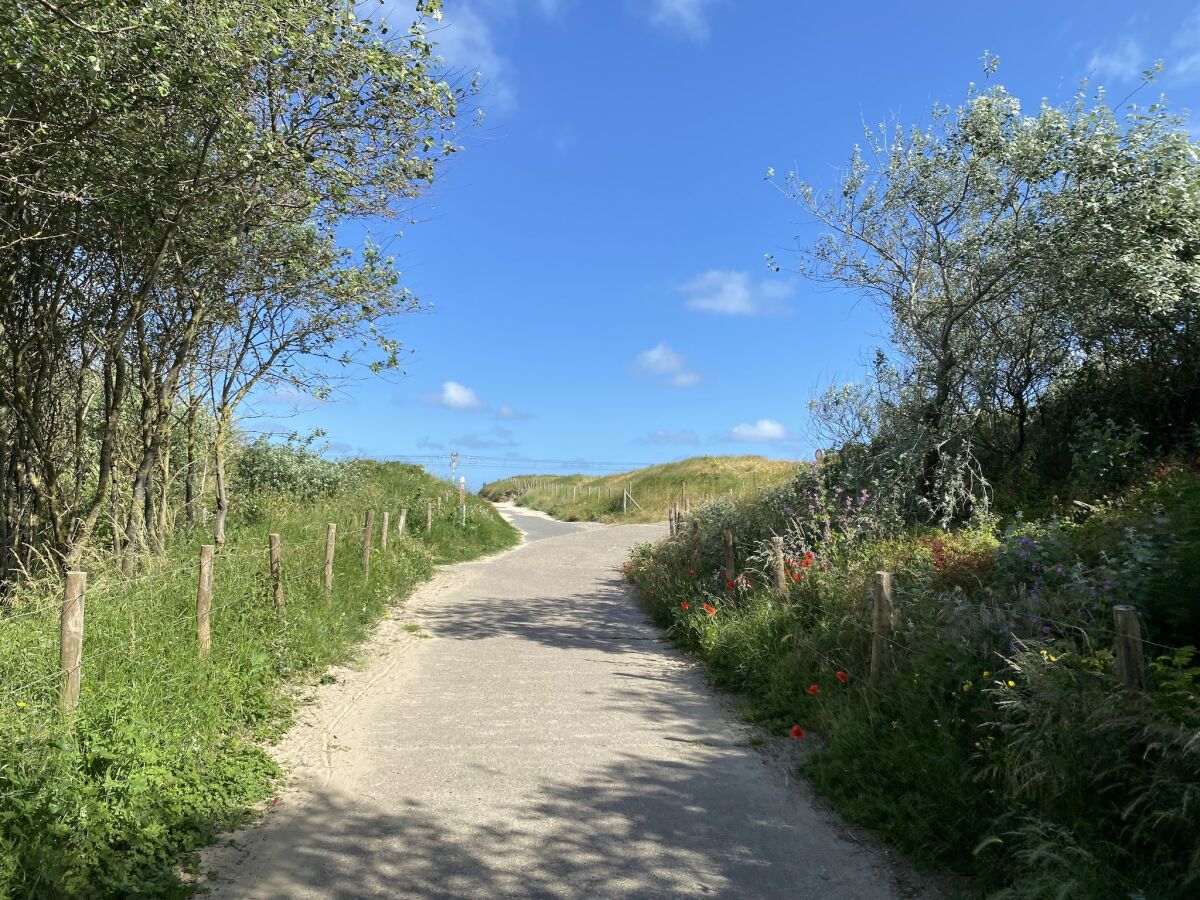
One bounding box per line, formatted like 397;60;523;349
626;460;1200;900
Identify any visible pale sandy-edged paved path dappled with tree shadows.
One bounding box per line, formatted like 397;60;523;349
204;510;912;900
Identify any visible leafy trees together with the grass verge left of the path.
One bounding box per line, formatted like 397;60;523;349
0;0;515;898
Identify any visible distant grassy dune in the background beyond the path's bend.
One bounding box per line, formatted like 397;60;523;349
480;456;796;522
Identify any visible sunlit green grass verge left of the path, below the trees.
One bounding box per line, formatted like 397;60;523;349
0;462;518;898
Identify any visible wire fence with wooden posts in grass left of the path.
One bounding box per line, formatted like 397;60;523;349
0;490;451;710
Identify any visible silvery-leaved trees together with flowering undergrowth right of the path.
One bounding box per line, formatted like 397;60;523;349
628;77;1200;899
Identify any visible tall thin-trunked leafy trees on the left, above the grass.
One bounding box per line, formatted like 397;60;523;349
0;0;464;573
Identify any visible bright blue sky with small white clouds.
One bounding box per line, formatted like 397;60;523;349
262;0;1200;486
